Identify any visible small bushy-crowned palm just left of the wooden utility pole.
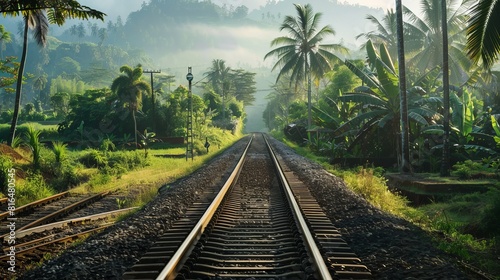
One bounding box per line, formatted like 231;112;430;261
111;65;151;148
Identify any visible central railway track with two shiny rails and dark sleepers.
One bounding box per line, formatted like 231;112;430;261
123;134;371;279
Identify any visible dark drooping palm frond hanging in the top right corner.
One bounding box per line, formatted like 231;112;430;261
467;0;500;68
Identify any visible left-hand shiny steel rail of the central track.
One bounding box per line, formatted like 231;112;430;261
156;135;255;280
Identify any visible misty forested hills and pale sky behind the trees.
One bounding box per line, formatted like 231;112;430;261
0;0;383;130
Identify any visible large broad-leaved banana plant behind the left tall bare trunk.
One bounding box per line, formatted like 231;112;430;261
334;41;437;156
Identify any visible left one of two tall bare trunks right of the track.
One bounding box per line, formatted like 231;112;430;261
396;0;411;173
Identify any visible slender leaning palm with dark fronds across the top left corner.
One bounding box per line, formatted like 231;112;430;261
0;0;105;145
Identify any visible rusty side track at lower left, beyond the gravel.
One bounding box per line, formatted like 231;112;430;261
0;192;133;276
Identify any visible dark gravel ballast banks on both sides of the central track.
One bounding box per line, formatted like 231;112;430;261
18;137;471;280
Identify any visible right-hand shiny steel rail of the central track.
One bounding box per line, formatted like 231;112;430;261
262;134;332;280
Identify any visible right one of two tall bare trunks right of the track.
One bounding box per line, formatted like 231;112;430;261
440;0;450;177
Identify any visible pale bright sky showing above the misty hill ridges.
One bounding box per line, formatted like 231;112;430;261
79;0;420;21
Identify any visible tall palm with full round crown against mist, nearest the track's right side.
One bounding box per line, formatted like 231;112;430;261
264;4;347;128
